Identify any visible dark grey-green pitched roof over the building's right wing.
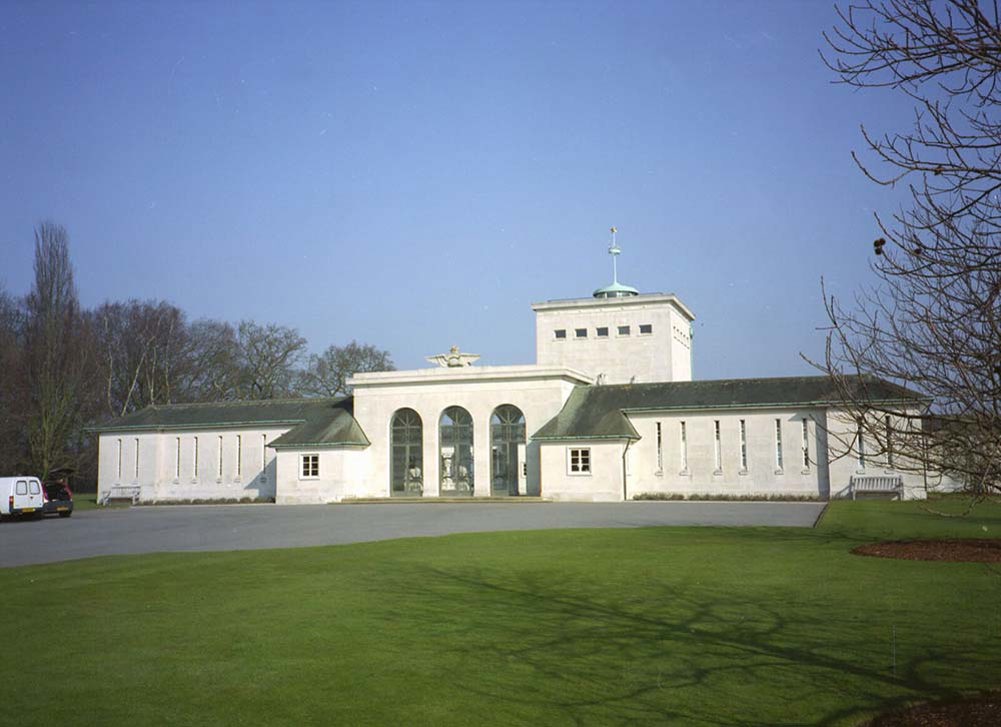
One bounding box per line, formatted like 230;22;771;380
533;377;923;440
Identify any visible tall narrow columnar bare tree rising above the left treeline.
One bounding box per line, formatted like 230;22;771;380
25;222;90;477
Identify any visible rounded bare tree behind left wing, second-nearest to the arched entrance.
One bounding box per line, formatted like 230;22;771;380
236;320;306;399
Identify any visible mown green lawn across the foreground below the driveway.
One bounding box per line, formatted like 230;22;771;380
0;502;1001;725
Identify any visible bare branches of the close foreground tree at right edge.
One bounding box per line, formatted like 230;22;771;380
822;0;1001;492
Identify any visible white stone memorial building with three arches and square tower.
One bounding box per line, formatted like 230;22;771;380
97;236;924;504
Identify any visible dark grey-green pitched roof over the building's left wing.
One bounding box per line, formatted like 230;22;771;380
91;398;368;447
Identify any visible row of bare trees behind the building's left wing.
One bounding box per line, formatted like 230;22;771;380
0;222;393;486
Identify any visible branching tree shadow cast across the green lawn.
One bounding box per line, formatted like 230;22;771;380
372;568;998;725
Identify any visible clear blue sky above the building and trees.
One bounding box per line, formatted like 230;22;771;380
0;1;911;379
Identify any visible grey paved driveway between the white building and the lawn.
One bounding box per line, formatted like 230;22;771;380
0;502;824;567
